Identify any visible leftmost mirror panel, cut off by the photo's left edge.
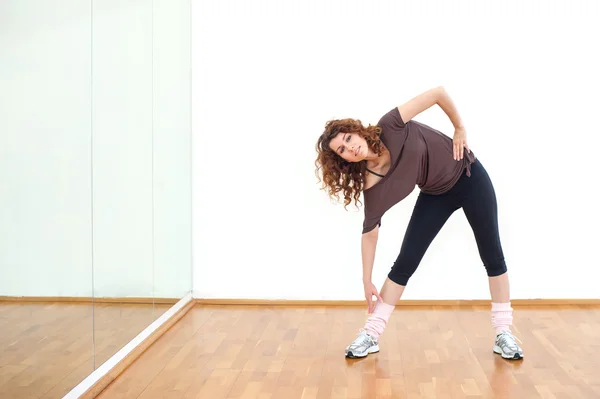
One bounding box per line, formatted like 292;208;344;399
0;0;94;398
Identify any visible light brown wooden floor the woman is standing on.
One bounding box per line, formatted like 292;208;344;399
99;305;600;399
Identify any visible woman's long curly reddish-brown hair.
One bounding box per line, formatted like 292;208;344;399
315;118;383;209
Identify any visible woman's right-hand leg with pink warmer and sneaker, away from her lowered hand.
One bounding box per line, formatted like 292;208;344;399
463;161;523;359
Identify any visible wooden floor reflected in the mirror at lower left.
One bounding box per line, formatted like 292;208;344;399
0;302;171;399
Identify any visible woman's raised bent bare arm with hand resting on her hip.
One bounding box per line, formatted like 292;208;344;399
398;86;471;161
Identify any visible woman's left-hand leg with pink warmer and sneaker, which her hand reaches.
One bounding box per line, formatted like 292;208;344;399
346;193;458;358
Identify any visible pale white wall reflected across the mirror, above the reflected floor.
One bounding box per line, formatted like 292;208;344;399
0;0;191;297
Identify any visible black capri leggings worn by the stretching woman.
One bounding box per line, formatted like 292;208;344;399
388;160;506;286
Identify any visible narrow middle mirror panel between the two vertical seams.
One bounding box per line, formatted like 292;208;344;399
91;0;156;368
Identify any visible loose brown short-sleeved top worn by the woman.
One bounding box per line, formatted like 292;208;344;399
363;107;475;234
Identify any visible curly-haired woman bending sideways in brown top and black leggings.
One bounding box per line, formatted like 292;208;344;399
316;87;523;359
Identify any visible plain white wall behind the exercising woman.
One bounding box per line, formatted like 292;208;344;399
192;0;600;299
